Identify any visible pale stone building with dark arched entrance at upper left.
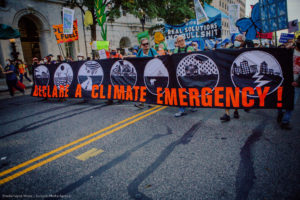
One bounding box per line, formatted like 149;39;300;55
0;0;156;65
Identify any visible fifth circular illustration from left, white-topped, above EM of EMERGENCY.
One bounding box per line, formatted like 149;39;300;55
144;58;169;95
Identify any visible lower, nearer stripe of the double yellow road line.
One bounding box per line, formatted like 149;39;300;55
0;106;167;185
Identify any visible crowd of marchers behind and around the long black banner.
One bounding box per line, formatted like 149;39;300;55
0;34;300;130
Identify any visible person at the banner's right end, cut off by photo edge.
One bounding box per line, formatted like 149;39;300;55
277;36;300;130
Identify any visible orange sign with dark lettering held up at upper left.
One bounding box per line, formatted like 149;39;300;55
52;20;78;44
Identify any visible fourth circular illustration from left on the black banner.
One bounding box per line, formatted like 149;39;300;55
110;60;137;91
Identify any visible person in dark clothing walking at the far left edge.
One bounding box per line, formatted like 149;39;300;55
0;59;25;97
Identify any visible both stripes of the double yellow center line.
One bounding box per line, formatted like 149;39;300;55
0;106;166;185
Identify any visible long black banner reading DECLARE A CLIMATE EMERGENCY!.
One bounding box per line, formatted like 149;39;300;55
31;48;294;109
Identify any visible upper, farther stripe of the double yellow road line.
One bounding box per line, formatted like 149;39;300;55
0;106;161;177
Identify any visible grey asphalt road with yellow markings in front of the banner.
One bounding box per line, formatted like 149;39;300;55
0;95;300;200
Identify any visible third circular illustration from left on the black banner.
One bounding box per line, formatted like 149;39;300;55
78;61;104;91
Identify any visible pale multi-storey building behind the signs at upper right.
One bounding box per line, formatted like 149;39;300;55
211;0;246;38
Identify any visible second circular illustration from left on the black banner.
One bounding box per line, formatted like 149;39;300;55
54;63;73;89
